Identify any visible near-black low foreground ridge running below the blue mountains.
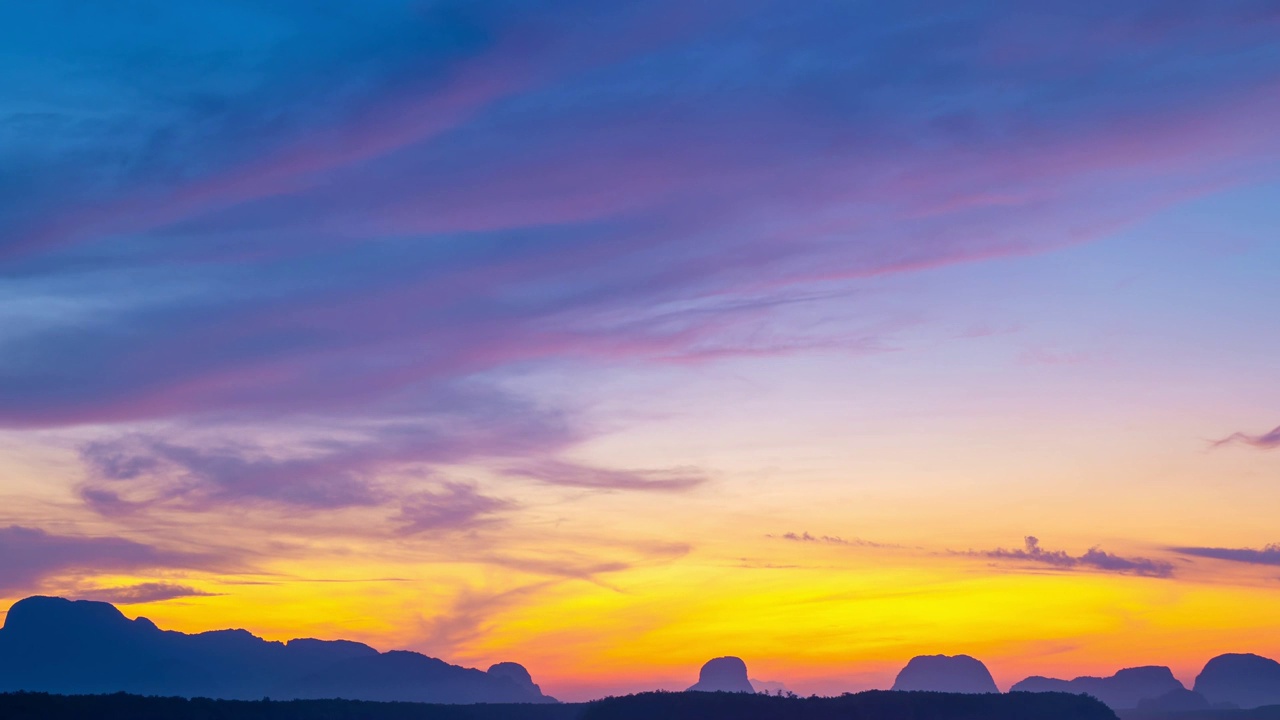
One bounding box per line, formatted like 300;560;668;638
0;691;1116;720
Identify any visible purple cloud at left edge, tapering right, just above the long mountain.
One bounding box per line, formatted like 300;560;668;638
0;525;237;593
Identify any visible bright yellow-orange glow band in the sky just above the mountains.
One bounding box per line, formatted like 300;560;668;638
12;532;1280;698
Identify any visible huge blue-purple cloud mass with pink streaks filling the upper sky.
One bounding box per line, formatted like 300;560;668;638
0;0;1280;435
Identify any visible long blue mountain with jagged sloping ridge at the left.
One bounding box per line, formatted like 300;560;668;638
0;597;556;703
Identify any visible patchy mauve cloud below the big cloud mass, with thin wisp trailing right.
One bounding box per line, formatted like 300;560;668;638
79;412;707;512
